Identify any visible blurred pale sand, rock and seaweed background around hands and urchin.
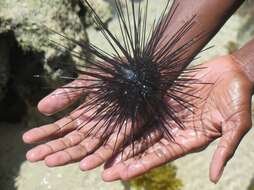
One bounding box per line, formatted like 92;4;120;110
0;0;254;190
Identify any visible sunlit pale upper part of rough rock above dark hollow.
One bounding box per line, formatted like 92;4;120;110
0;0;87;84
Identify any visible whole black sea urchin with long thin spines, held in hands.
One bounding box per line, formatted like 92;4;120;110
45;0;206;157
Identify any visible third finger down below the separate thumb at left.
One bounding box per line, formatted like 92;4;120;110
45;137;101;167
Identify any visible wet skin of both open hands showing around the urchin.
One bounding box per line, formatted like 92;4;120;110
23;55;253;183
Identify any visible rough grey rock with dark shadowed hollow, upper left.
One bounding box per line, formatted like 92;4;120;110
0;0;88;122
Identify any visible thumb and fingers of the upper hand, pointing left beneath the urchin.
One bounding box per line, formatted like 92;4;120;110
23;76;139;170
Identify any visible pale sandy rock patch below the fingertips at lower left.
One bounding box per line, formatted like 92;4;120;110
15;162;124;190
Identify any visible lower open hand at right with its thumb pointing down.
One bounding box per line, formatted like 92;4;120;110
100;56;253;183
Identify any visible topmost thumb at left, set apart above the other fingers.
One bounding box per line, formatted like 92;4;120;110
38;79;86;115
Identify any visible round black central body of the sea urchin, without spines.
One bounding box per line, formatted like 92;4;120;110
107;60;163;118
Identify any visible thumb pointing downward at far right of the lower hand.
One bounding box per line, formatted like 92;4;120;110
210;116;251;183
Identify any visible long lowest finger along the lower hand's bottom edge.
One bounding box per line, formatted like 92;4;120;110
102;129;210;181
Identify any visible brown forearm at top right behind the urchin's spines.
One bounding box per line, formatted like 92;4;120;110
161;0;244;60
